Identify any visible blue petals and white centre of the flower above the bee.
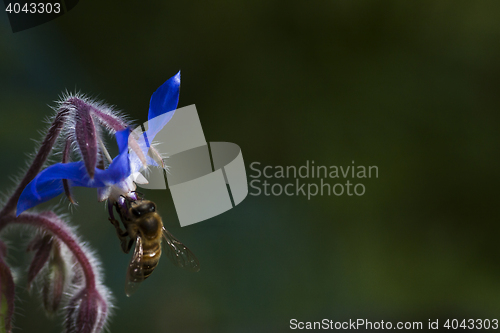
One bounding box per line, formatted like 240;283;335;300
17;72;180;215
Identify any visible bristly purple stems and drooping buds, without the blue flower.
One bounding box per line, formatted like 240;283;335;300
0;96;119;333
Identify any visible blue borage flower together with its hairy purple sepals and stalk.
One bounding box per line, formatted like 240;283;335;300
17;72;180;216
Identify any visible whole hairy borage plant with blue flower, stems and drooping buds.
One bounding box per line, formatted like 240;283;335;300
0;73;180;333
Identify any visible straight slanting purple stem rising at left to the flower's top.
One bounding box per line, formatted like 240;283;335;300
0;108;69;218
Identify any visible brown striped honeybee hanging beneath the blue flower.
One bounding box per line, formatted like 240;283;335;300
109;198;200;296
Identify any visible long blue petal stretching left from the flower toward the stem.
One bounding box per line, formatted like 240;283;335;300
17;129;130;215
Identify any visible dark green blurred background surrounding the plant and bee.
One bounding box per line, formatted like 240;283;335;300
0;0;500;333
